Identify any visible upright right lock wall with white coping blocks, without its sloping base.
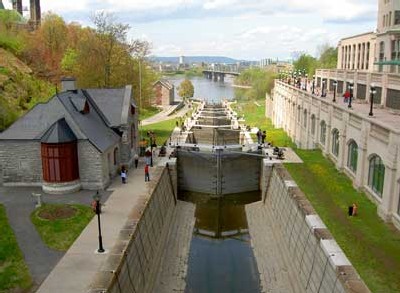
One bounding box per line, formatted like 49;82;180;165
249;162;370;293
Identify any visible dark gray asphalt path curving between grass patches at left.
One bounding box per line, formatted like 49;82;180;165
0;187;110;291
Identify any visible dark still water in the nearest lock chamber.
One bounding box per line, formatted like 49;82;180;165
182;192;260;293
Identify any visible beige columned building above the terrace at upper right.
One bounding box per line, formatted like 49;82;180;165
316;0;400;113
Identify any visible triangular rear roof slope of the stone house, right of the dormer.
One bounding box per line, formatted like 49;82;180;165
86;88;125;127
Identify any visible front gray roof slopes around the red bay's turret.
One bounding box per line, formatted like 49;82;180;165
0;91;120;152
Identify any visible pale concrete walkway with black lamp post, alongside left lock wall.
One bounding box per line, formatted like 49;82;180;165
37;158;160;293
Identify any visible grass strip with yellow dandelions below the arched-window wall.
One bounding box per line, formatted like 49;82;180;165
238;99;400;293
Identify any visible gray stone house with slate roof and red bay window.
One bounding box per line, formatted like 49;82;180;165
0;78;138;193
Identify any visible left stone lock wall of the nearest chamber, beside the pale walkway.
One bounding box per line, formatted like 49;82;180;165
89;164;177;293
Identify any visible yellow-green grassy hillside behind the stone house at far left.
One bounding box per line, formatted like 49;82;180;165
0;48;55;131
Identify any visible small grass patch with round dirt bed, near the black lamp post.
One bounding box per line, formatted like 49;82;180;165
31;204;94;251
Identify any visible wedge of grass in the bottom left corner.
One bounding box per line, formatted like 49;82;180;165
0;205;32;292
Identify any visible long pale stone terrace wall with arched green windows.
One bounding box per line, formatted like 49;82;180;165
266;81;400;229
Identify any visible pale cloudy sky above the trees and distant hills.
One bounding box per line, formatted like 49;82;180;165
3;0;378;60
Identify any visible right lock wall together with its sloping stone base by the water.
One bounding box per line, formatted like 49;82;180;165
246;161;370;293
